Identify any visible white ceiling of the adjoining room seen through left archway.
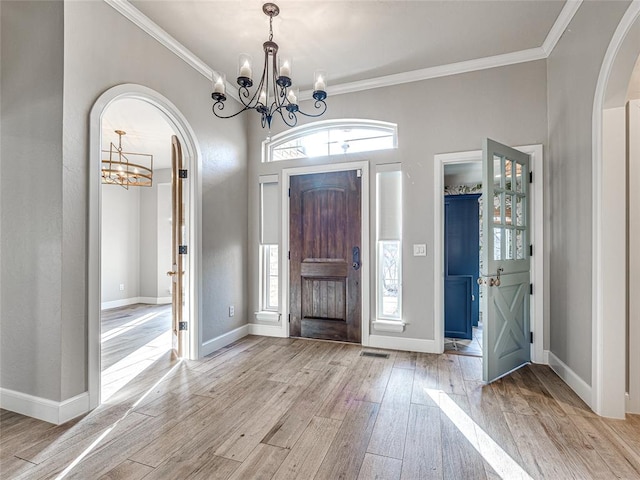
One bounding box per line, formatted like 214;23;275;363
102;98;174;170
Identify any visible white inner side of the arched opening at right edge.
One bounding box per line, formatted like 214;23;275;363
591;1;640;418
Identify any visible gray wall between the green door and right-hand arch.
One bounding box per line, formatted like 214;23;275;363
547;2;628;384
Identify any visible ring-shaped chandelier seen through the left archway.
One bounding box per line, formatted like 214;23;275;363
102;130;153;190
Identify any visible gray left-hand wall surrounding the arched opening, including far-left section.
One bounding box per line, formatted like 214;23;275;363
1;2;247;401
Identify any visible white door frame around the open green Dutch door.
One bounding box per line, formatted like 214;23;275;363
433;145;549;364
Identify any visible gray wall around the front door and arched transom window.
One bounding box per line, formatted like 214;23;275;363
249;61;547;339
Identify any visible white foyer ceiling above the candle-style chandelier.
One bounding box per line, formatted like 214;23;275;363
130;0;565;90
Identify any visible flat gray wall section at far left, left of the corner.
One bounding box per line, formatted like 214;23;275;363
0;1;65;400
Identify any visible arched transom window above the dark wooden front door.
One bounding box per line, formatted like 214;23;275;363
263;119;398;162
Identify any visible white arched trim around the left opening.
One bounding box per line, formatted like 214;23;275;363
87;84;202;409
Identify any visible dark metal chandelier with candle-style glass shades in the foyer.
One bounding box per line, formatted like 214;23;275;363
211;3;327;128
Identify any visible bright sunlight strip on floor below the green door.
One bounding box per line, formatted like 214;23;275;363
425;388;533;480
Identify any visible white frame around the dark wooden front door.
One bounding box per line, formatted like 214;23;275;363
280;161;371;346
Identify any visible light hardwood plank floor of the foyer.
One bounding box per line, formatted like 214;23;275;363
0;336;640;480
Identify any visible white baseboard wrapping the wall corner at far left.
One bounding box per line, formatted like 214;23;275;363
0;388;89;425
